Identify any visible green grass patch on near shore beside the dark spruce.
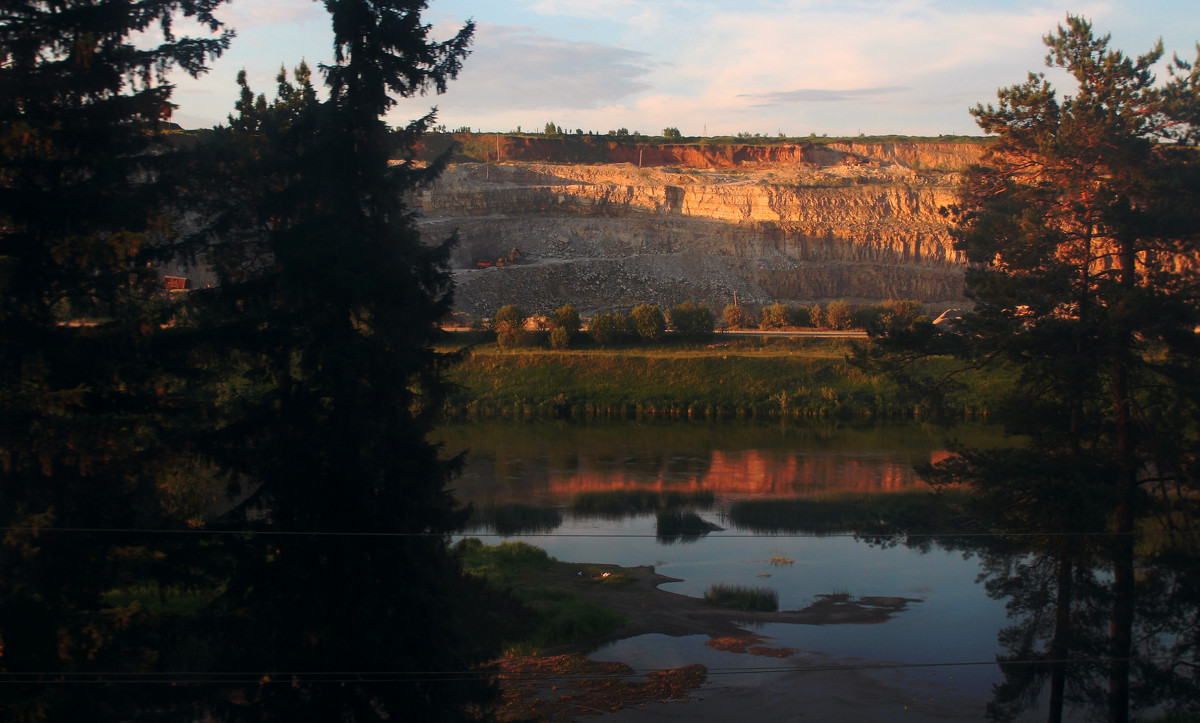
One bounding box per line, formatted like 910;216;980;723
452;538;629;652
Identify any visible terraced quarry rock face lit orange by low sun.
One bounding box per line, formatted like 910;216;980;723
414;138;985;316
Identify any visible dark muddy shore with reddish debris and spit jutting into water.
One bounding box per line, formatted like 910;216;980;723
492;564;982;723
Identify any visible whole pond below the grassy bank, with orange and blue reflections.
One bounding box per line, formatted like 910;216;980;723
439;422;1195;719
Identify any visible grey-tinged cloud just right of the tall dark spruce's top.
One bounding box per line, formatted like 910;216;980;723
424;24;658;113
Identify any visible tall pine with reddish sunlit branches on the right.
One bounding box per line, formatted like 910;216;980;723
921;17;1200;721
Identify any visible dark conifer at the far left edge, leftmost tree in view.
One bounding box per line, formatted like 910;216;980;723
0;0;232;721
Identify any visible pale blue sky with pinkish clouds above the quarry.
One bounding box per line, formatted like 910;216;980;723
166;0;1200;137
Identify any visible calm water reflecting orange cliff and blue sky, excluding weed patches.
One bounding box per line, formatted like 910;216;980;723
440;422;1187;719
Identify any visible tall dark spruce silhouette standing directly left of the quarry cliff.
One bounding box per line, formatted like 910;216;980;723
188;0;488;721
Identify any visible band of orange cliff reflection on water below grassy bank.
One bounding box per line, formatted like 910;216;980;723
439;422;979;506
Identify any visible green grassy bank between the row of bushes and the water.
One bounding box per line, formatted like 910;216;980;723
448;339;1006;418
